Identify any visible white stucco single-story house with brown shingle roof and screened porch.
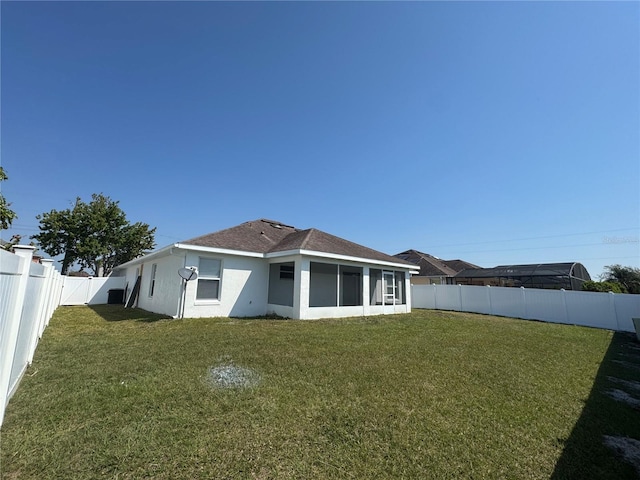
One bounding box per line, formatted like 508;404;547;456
114;219;416;319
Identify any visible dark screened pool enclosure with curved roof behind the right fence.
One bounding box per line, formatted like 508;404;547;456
449;262;591;290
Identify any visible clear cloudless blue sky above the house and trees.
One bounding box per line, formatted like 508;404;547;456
0;1;640;277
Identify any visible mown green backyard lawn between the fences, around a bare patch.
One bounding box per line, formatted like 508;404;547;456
0;305;640;480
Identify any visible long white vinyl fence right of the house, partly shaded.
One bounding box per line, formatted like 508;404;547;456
411;285;640;332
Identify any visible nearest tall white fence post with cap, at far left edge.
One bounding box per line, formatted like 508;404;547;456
0;245;36;425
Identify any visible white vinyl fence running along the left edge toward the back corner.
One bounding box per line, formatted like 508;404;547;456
0;246;62;425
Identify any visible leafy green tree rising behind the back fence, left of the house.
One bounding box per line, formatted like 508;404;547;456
31;193;156;275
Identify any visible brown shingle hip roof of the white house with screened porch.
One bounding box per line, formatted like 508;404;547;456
181;218;413;265
